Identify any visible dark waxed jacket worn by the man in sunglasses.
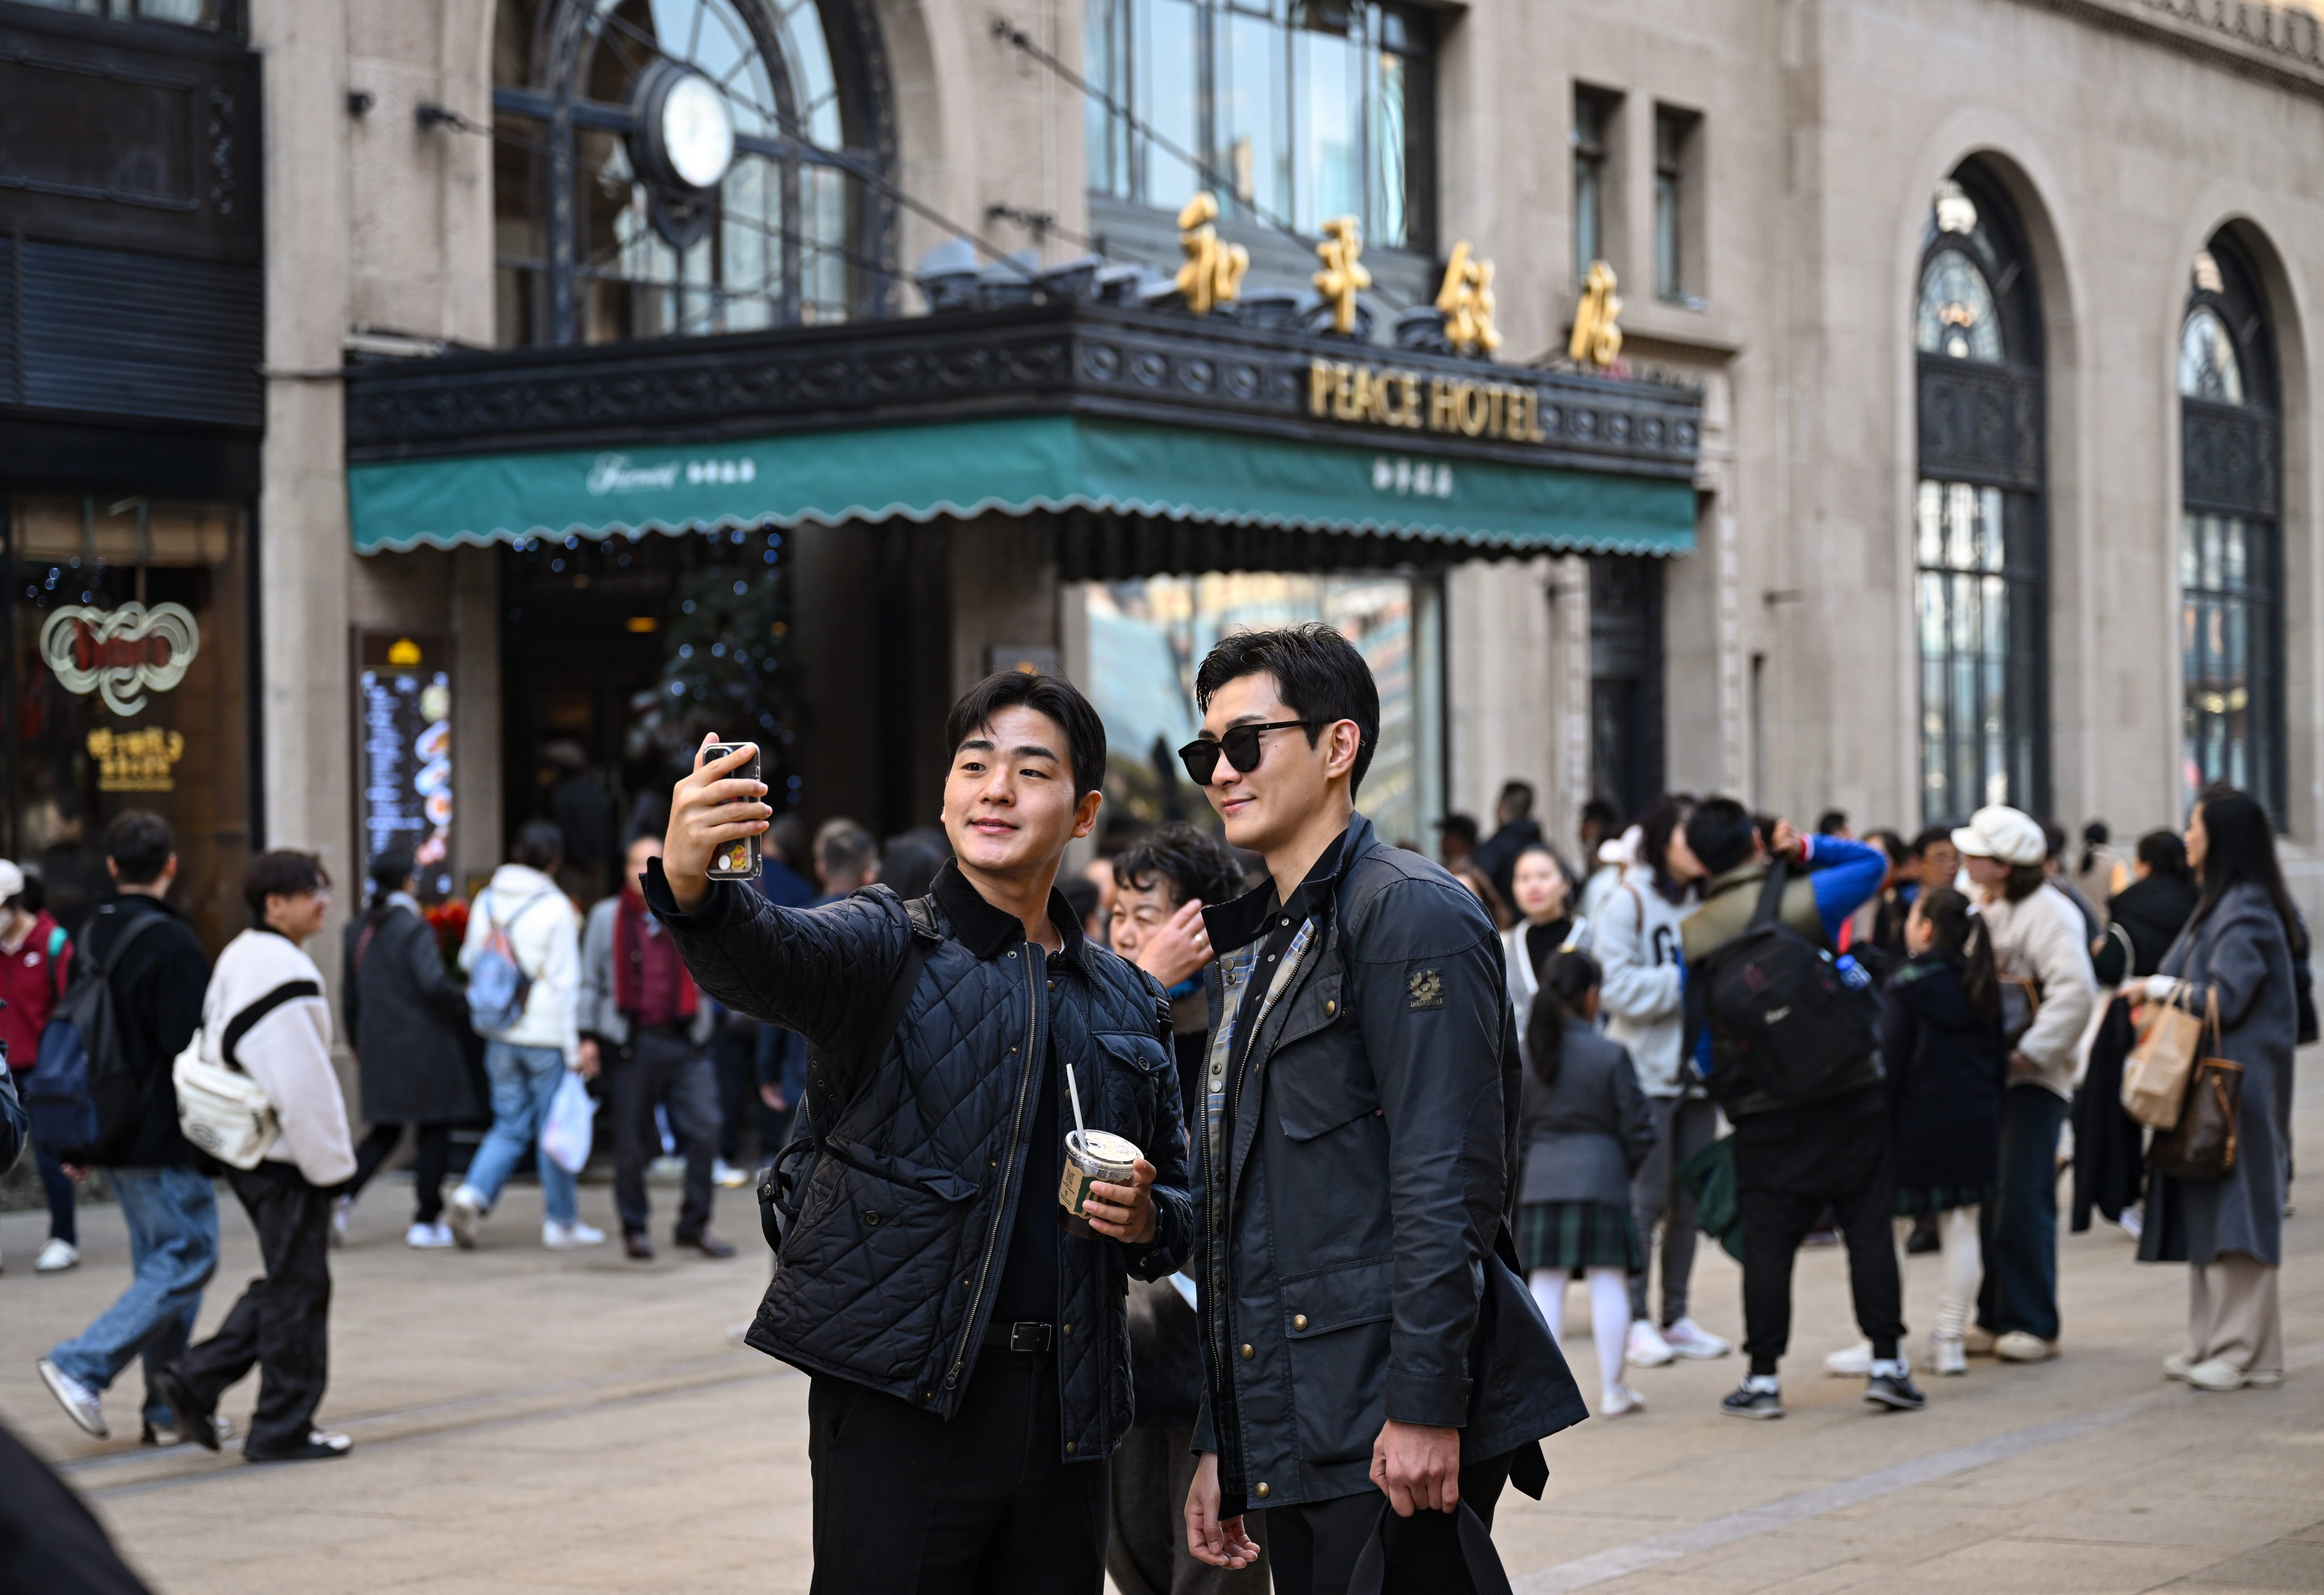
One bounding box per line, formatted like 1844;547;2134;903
1195;814;1587;1516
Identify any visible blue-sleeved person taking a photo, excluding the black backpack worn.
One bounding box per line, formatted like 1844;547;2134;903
1678;814;1927;1419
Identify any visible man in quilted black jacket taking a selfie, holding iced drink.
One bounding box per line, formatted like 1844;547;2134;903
646;672;1192;1595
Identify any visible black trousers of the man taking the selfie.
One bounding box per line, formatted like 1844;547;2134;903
806;1349;1108;1595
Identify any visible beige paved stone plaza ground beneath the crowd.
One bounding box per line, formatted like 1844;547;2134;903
0;1088;2324;1595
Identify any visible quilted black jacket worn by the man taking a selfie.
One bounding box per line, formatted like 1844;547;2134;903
646;860;1195;1462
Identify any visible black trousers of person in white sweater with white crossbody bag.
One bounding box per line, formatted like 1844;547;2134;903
176;1163;333;1453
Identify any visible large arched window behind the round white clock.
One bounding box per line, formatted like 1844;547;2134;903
493;0;892;344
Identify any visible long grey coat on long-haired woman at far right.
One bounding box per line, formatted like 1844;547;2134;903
2138;881;2301;1267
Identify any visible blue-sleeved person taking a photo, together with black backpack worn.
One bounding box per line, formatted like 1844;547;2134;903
1680;798;1927;1419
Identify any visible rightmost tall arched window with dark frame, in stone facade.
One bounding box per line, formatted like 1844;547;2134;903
2180;233;2284;818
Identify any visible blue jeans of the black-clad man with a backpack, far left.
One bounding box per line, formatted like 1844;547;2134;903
49;1169;218;1428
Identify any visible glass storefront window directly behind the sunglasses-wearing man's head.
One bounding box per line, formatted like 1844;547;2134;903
1087;572;1443;841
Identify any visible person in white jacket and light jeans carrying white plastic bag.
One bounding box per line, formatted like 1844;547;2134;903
444;820;604;1251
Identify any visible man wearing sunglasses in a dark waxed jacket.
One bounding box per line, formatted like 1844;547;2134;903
1180;625;1587;1595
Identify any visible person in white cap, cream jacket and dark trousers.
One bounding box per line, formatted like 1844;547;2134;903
1952;805;2099;1362
